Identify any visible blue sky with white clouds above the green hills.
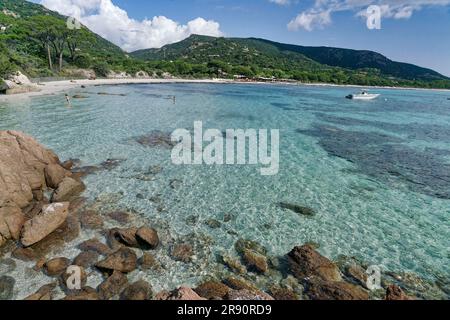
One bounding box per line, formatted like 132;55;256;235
34;0;450;76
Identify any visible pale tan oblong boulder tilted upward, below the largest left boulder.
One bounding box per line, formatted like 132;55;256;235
20;202;69;247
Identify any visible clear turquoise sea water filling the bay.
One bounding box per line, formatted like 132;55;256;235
0;84;450;287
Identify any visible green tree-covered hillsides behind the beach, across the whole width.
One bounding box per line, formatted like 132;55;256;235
0;0;450;88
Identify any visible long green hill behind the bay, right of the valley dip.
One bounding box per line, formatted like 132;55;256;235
131;35;450;88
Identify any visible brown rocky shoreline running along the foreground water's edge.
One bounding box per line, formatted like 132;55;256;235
0;131;449;300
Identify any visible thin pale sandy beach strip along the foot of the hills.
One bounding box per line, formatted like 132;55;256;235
0;78;450;102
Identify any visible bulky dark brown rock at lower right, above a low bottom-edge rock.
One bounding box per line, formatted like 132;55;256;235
288;245;342;281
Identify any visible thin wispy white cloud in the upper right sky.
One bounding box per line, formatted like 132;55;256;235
288;0;450;31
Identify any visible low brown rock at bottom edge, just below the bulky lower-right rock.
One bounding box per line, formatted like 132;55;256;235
305;279;369;300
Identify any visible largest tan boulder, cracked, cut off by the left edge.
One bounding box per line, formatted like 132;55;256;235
0;131;66;209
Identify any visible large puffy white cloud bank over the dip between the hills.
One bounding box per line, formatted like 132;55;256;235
41;0;223;51
